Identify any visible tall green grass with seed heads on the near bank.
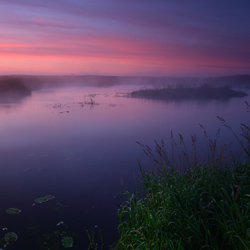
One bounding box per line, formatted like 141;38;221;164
113;103;250;250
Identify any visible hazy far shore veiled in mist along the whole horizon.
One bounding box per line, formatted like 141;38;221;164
0;74;250;90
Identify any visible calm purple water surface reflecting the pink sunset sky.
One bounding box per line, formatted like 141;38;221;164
0;85;250;250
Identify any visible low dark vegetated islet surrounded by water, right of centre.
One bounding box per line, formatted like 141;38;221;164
130;84;247;101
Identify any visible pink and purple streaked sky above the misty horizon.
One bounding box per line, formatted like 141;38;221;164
0;0;250;76
